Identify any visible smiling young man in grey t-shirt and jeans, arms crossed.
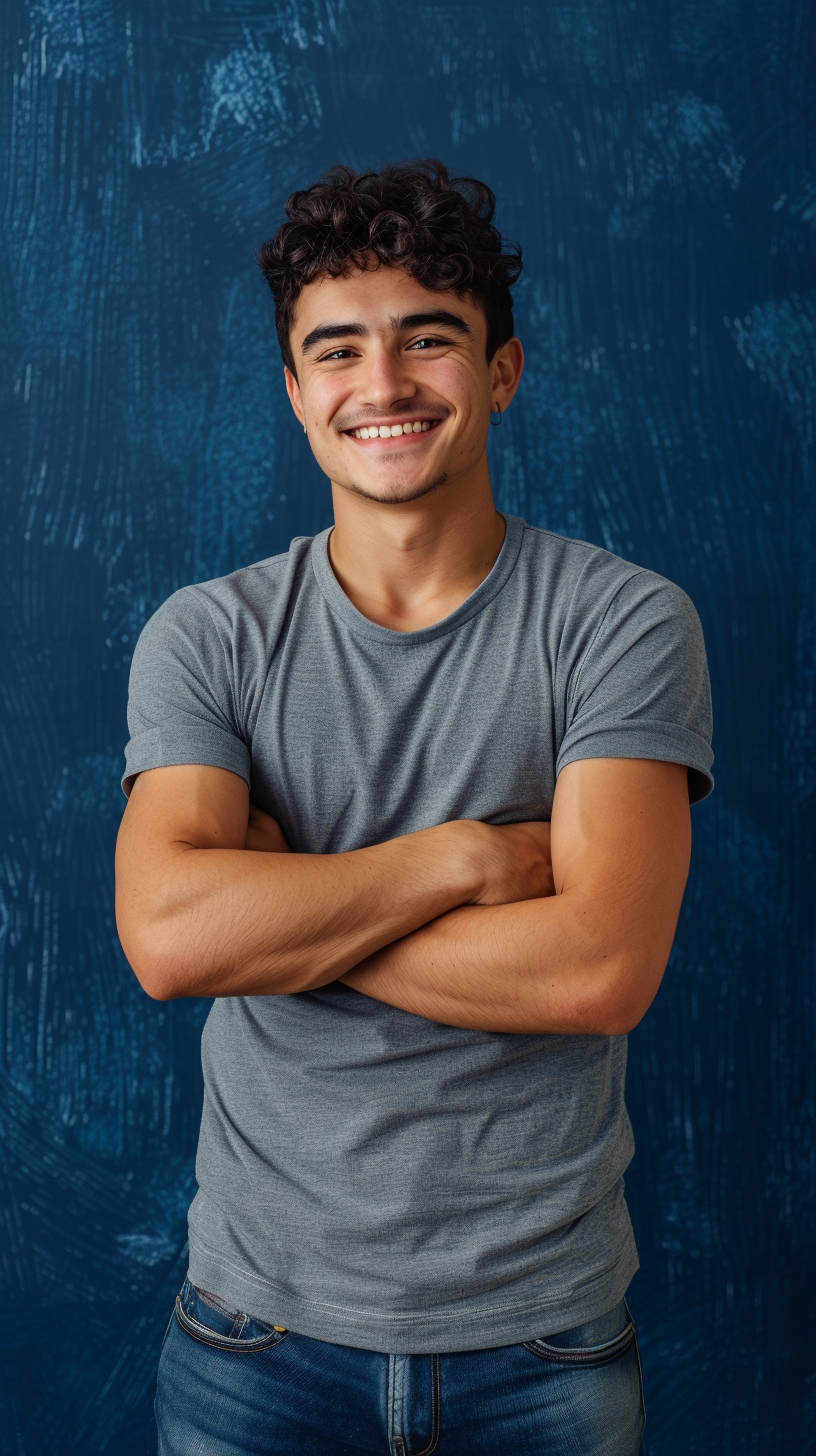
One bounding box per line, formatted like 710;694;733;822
118;163;711;1456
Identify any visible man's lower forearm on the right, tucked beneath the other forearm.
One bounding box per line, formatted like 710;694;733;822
342;895;670;1035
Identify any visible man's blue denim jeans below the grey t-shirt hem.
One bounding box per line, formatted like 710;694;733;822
156;1280;644;1456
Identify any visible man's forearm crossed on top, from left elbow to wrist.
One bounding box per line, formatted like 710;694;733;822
118;826;476;999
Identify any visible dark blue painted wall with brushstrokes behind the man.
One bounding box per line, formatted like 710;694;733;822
0;0;816;1456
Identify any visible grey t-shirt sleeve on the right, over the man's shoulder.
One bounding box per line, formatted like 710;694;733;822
557;572;714;804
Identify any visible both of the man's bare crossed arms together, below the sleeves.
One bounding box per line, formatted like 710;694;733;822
117;759;691;1034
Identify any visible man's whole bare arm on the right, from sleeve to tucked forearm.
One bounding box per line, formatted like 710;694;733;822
342;759;691;1035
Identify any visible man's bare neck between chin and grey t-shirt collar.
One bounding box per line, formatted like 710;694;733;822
329;460;504;632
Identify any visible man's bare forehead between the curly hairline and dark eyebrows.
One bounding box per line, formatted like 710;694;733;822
291;268;485;345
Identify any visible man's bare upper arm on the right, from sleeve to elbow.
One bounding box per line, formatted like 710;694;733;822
552;759;691;1015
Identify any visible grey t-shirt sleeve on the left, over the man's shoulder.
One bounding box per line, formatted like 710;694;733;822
122;587;251;794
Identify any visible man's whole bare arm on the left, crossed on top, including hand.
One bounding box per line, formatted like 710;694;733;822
117;764;552;1000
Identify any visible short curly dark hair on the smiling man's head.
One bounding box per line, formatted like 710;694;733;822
256;159;522;373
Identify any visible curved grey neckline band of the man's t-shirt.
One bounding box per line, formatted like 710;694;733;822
310;511;525;646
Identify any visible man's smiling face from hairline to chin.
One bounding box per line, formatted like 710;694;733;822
286;268;520;504
